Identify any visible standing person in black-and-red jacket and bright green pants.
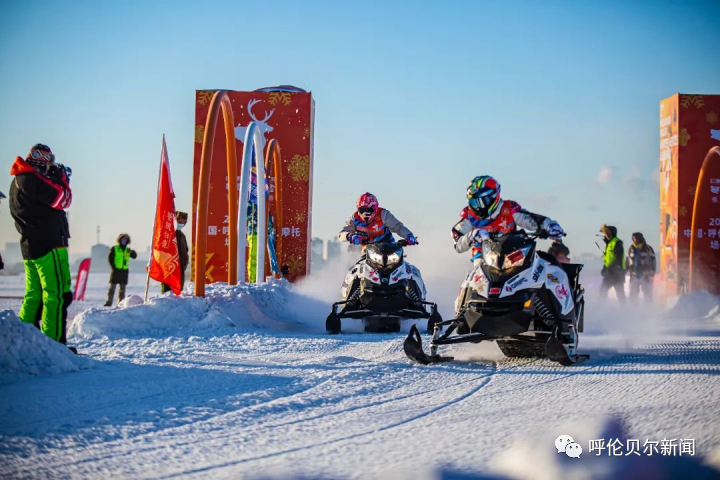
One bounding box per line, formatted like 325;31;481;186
10;143;72;343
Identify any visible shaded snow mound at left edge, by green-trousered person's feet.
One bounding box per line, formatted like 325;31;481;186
0;310;93;375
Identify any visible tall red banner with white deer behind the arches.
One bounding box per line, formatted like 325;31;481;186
192;90;315;283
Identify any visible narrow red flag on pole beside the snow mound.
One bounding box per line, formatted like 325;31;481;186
149;136;181;295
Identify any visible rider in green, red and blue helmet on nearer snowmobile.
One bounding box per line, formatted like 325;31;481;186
452;175;565;261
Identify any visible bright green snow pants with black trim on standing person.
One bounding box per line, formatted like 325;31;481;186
20;247;72;343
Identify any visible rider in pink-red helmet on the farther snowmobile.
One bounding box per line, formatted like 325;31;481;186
338;192;418;245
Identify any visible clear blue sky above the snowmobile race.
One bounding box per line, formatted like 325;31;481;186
0;0;720;253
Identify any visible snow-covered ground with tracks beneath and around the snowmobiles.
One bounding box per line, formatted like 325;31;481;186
0;260;720;479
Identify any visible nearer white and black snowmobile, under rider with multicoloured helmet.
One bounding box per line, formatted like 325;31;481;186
404;230;589;366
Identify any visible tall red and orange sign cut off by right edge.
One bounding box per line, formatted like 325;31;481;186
660;94;720;295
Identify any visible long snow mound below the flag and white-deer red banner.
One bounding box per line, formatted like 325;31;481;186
69;281;330;337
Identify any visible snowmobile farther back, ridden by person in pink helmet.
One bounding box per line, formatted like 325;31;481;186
325;240;442;334
